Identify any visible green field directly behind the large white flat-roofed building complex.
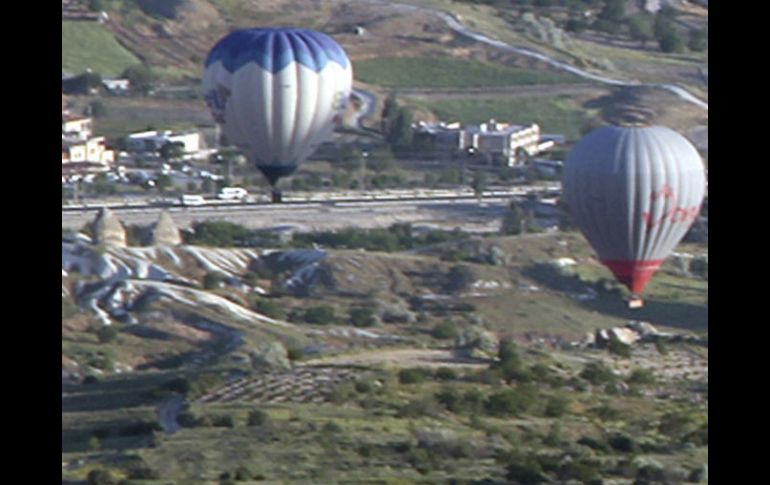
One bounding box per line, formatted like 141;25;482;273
410;96;596;140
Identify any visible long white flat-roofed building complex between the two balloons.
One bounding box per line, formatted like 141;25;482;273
414;120;553;166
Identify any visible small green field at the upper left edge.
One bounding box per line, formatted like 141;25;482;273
61;20;140;76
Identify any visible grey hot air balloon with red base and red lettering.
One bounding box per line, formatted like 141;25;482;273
562;126;706;308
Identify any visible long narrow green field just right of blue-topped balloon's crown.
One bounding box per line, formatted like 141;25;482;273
353;57;581;88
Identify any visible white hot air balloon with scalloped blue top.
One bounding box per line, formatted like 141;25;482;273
203;28;353;201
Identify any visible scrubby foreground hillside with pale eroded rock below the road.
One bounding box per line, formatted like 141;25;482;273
62;229;708;483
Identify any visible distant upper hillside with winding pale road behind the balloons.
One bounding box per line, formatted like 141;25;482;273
63;0;708;140
